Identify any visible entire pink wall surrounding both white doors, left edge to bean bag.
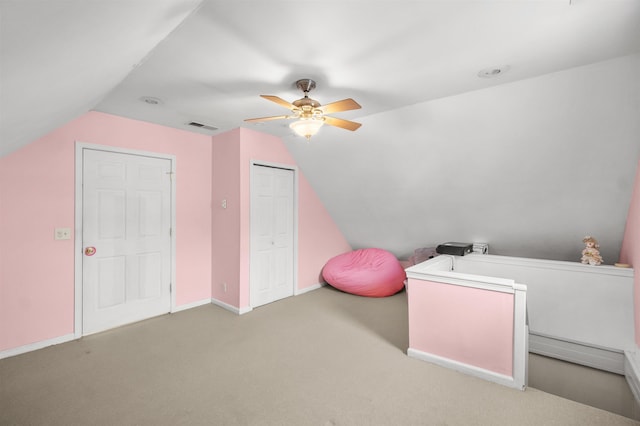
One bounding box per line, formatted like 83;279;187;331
0;112;351;351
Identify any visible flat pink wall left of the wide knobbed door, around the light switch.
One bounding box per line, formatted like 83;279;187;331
0;135;74;350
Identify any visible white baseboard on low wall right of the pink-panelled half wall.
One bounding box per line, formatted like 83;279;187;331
529;333;625;374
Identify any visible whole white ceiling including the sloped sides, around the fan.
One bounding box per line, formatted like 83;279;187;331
0;0;640;263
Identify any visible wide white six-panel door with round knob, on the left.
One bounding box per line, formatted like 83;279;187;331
82;149;172;334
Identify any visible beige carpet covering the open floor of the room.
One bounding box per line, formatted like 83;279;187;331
0;287;638;426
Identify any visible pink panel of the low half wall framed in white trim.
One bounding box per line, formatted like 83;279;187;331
408;279;514;376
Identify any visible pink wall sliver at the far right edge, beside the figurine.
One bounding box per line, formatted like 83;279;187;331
620;158;640;345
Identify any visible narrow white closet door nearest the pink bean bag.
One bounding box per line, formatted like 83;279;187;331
250;165;294;308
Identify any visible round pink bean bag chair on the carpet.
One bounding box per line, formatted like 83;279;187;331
322;248;407;297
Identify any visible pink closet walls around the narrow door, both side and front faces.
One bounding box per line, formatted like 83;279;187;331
212;128;351;309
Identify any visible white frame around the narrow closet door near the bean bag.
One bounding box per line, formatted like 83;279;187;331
247;160;300;309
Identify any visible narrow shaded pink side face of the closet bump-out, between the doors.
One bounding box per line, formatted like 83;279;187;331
211;130;241;307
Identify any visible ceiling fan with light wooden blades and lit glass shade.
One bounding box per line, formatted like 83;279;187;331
244;78;362;139
